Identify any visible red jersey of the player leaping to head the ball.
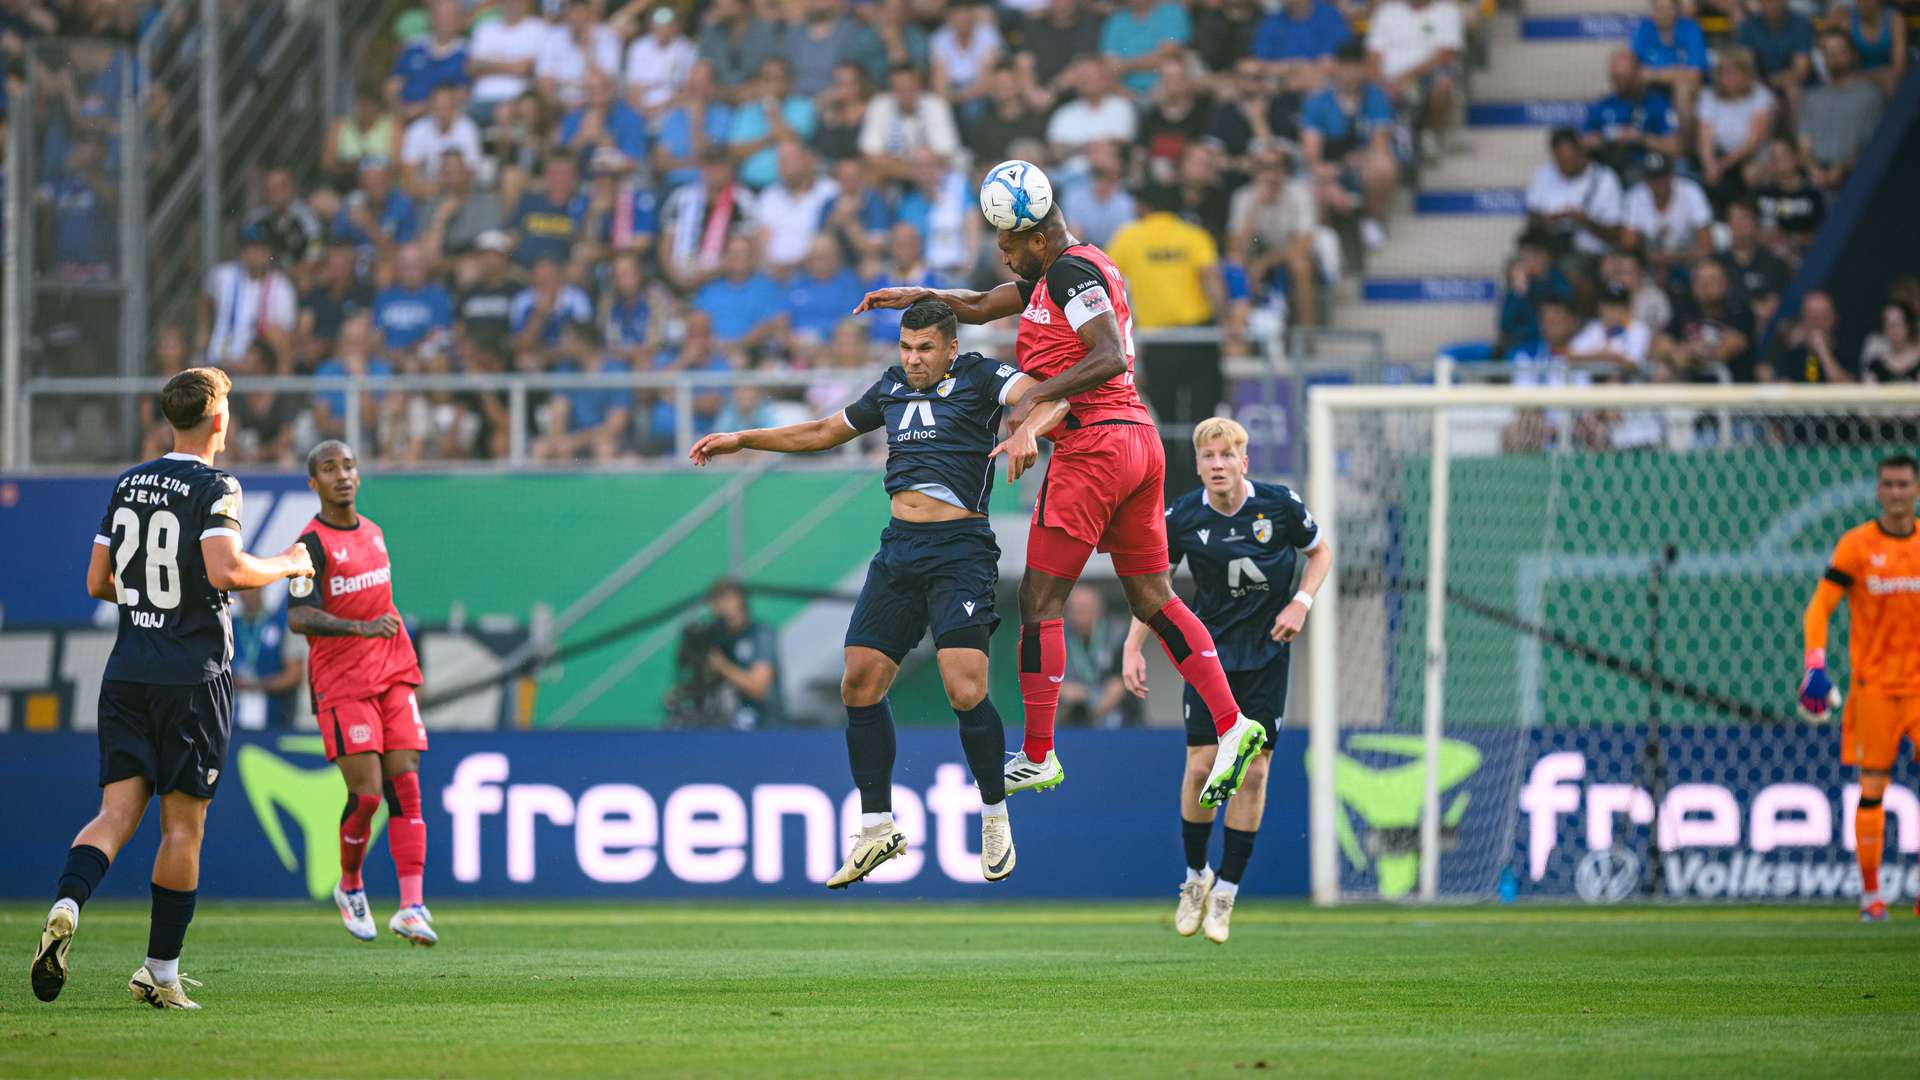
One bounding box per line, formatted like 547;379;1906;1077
1014;244;1154;442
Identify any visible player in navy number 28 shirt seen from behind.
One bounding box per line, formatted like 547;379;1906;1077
31;367;313;1009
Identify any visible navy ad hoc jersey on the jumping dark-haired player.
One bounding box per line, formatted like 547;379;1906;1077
847;352;1023;513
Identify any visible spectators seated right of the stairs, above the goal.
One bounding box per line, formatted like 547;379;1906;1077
1496;0;1920;446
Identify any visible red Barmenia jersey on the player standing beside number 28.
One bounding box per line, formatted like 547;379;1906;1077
286;515;420;709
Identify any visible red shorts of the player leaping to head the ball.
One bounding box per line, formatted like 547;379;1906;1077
1027;423;1167;580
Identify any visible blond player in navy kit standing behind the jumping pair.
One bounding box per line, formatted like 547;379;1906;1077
1121;417;1332;944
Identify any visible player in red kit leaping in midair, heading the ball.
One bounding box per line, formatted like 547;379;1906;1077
854;206;1265;807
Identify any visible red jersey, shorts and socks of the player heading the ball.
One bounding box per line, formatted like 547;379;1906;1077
1014;244;1240;763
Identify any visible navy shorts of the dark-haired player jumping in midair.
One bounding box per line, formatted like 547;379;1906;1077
847;517;1000;663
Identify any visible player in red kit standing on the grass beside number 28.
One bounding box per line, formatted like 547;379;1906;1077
286;438;440;945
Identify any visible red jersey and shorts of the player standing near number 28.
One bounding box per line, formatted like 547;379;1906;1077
288;517;426;761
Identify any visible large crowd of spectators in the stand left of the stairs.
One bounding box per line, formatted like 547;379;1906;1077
127;0;1463;463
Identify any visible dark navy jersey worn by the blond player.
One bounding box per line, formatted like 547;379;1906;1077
1167;480;1319;671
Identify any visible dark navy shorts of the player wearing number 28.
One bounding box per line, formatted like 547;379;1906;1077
98;675;234;799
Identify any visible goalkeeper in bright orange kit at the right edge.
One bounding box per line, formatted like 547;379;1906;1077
1801;454;1920;922
